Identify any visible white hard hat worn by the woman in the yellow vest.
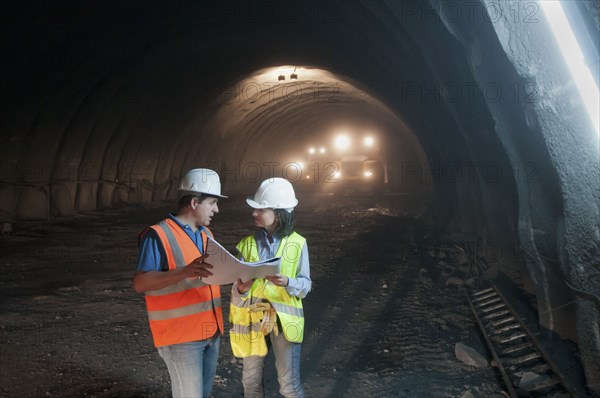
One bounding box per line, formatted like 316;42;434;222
246;177;298;213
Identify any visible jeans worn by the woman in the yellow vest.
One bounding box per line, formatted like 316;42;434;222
242;332;304;398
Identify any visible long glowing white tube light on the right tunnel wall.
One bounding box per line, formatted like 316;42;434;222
540;0;600;135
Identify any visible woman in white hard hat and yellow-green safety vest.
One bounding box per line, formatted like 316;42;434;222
229;178;312;397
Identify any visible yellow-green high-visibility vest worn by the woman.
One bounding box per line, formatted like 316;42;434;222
229;232;306;358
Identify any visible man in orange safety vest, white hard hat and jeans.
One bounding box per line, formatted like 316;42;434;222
133;169;226;397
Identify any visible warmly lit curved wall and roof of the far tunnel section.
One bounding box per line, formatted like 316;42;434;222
186;66;431;196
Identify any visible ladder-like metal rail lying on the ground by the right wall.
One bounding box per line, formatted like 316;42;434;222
467;285;575;398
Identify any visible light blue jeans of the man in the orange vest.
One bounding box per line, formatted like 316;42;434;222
157;332;221;398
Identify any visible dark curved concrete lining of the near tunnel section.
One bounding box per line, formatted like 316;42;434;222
0;1;600;388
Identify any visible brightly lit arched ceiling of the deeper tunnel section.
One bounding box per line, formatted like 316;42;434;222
185;66;427;189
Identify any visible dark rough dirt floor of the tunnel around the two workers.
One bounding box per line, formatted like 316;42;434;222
0;194;584;398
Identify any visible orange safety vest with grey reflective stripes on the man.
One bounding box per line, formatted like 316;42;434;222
146;219;223;347
